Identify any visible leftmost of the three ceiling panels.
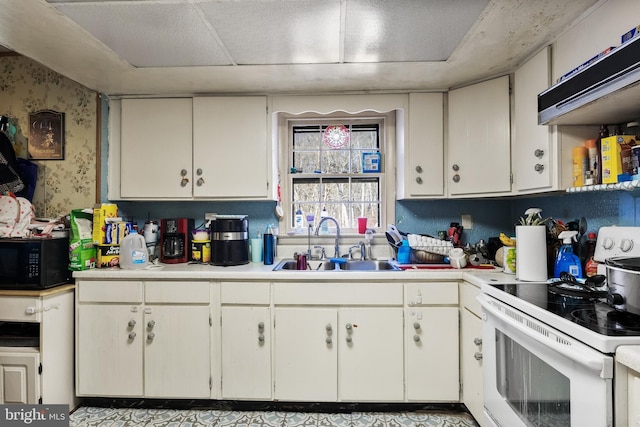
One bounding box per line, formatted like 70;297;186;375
53;1;232;67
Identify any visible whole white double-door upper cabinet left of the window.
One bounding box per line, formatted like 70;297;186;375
115;96;272;200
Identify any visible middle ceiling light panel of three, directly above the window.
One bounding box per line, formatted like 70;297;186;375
198;0;340;65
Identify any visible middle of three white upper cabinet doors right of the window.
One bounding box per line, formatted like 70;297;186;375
446;76;511;196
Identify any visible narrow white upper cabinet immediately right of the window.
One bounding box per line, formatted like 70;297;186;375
398;93;444;199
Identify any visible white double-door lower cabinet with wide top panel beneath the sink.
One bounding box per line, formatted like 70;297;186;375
274;283;404;402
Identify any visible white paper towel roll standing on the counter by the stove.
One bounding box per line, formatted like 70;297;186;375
516;225;547;282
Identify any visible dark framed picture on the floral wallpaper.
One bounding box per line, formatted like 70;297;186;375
28;110;64;160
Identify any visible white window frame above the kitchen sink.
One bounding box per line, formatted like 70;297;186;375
278;111;396;237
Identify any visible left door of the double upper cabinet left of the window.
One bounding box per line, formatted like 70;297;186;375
120;98;192;199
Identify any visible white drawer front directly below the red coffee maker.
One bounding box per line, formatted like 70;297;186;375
144;282;211;304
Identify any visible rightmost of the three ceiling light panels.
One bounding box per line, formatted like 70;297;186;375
345;0;488;62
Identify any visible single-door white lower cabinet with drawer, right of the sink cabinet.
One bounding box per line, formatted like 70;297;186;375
405;282;460;402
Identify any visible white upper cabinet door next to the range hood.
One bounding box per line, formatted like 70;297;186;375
512;48;558;192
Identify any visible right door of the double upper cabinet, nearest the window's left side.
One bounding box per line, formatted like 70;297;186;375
193;96;270;199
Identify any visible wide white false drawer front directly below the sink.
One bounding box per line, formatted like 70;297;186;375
273;283;402;306
